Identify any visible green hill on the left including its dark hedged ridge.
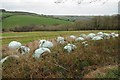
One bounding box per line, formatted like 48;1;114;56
0;12;72;29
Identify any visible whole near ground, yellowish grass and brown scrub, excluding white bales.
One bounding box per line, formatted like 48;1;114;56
2;31;120;78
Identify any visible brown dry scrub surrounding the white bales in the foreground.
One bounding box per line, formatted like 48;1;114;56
2;34;120;78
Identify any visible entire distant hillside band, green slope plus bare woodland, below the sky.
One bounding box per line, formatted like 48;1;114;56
0;11;119;32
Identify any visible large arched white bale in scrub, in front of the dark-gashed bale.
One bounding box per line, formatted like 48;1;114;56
33;48;51;58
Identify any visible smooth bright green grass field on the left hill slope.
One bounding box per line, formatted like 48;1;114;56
2;15;72;29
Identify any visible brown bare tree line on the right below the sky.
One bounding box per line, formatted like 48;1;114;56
71;15;120;30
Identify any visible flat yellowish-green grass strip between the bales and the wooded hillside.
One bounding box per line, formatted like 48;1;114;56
2;30;118;45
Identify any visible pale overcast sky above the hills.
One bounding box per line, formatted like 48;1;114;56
0;0;120;15
